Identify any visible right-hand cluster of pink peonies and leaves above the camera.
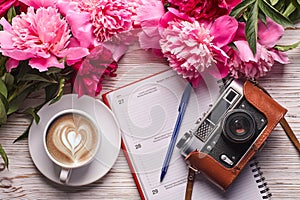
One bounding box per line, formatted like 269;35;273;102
137;0;299;87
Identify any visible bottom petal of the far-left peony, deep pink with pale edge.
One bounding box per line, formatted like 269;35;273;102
29;56;65;72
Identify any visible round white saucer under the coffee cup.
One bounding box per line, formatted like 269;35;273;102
28;94;121;186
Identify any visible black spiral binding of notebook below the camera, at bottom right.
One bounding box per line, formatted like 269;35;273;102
250;160;272;199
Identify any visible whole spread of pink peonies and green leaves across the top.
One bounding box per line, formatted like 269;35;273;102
0;0;300;164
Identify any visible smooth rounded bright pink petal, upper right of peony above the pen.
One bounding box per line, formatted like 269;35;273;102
210;15;238;48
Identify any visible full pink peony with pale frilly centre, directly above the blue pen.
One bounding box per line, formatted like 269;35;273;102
160;16;238;87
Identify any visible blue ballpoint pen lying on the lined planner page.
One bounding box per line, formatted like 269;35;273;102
160;83;192;182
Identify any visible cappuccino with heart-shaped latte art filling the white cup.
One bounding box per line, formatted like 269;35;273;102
46;112;99;168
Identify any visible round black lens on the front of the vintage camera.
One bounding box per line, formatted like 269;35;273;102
223;109;255;143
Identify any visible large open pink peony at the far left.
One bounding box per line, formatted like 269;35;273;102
0;7;89;71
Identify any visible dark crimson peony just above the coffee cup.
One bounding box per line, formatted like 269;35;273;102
73;46;118;96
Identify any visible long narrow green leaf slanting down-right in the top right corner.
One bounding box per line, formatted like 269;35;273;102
258;0;294;27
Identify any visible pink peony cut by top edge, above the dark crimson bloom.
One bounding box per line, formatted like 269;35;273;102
56;0;137;61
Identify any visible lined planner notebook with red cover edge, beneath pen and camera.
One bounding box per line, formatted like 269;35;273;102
103;70;271;200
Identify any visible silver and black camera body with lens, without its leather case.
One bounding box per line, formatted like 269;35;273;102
176;79;267;168
